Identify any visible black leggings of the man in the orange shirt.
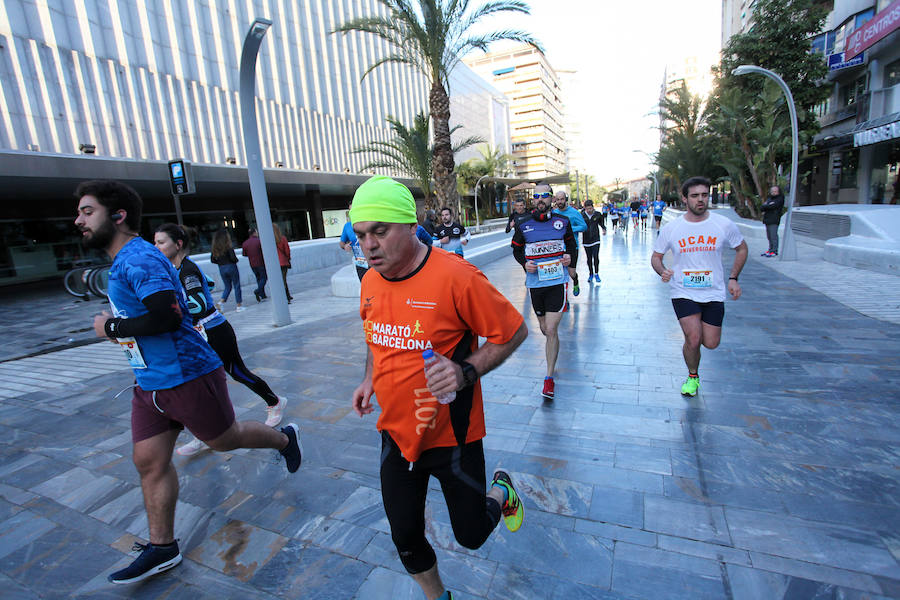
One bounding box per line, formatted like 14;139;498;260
381;432;500;575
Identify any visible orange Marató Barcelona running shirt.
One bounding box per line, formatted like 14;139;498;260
359;248;524;462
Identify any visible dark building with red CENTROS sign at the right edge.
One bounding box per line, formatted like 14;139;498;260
798;0;900;204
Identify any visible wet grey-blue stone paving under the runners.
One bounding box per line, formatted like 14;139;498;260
0;227;900;600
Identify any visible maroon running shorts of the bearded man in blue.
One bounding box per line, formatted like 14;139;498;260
131;367;234;444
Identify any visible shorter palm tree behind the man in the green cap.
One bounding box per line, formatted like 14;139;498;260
351;111;483;208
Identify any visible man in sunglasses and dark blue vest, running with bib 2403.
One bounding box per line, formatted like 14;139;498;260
512;182;575;400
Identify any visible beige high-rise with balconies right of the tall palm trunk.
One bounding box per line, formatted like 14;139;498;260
465;45;566;179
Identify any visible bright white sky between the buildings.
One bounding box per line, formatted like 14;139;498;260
472;0;722;184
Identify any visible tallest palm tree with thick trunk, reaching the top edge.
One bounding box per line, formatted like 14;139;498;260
333;0;541;206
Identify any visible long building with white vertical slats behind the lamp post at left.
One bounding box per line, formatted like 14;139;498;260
0;0;509;284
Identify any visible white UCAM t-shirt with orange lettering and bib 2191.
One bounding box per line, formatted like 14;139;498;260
653;212;744;302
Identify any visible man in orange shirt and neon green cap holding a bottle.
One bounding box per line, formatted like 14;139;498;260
350;176;528;600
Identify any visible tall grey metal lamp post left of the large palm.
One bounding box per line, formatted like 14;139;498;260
240;18;291;326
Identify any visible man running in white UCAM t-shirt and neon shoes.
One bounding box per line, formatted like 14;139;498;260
650;177;747;396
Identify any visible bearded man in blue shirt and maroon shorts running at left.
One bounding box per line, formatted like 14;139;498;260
75;181;302;584
